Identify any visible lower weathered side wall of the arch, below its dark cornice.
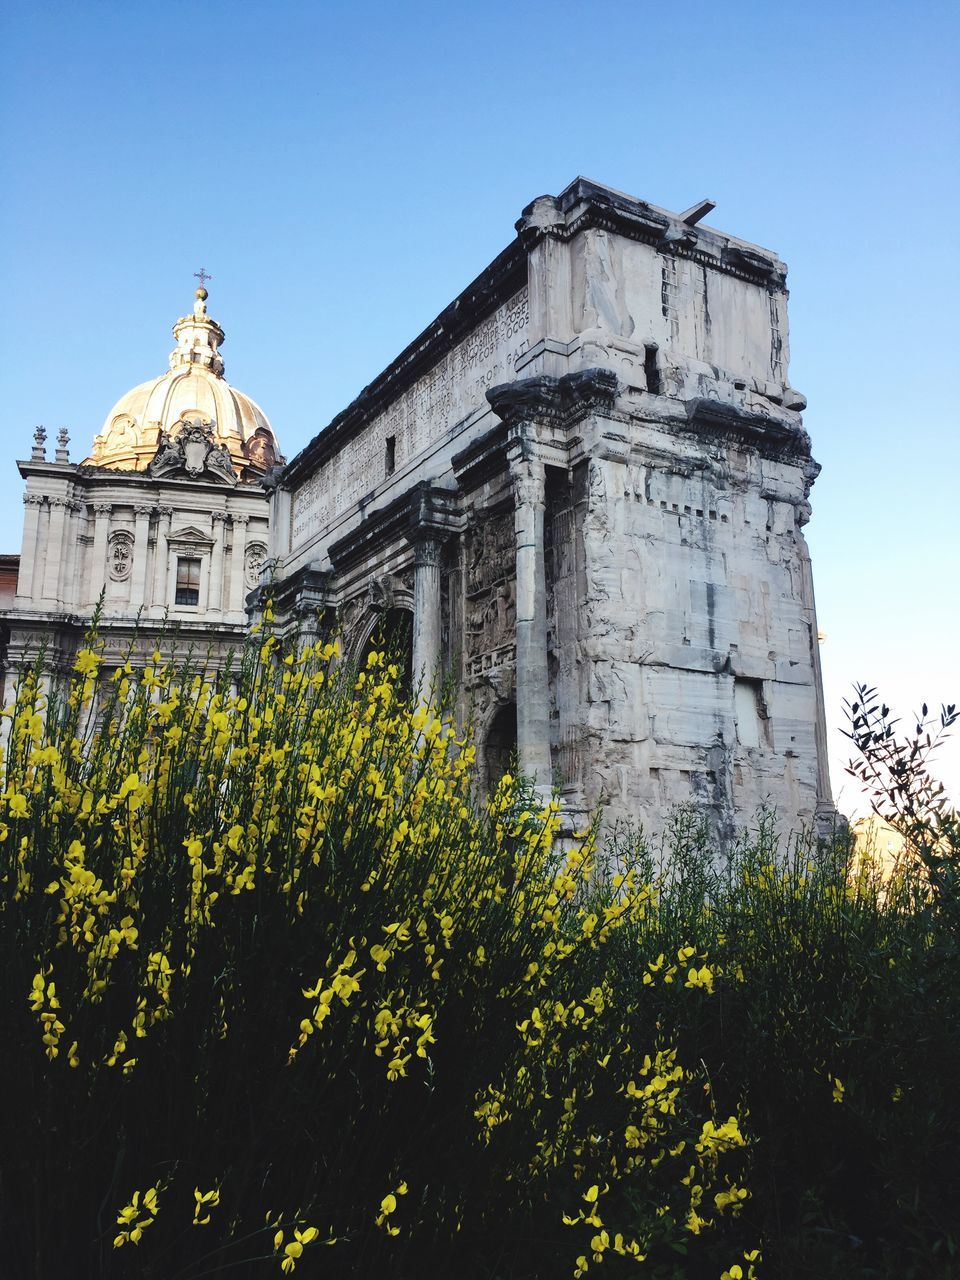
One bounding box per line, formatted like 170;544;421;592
557;429;818;827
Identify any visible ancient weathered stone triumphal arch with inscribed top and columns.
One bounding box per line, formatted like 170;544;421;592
263;179;832;832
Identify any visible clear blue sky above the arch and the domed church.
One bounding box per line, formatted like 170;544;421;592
0;0;960;808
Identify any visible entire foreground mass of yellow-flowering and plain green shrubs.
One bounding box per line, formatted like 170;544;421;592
0;635;960;1280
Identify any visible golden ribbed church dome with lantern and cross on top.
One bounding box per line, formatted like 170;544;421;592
86;288;283;480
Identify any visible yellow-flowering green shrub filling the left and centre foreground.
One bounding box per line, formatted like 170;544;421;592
0;636;750;1280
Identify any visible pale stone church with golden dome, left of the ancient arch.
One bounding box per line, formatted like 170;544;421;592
3;287;283;691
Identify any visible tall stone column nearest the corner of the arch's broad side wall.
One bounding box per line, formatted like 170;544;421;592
509;448;552;788
